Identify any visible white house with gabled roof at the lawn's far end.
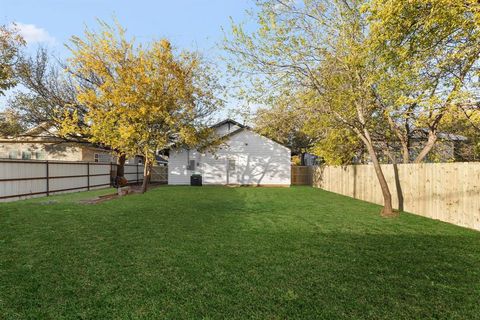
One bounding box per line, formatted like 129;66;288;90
168;119;290;186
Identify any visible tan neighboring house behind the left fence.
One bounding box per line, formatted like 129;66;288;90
0;124;116;163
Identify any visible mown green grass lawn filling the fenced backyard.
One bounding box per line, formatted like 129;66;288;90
0;187;480;319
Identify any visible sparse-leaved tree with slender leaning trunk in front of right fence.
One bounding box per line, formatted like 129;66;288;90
226;0;400;216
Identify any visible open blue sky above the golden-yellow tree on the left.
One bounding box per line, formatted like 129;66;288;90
0;0;254;117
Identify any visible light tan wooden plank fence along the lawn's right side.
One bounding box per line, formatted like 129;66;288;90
313;162;480;230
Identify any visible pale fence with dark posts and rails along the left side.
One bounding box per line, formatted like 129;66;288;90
0;160;143;201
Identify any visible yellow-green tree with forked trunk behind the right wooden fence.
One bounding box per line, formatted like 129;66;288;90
363;0;480;163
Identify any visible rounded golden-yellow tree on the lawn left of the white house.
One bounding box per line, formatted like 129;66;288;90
63;22;221;191
